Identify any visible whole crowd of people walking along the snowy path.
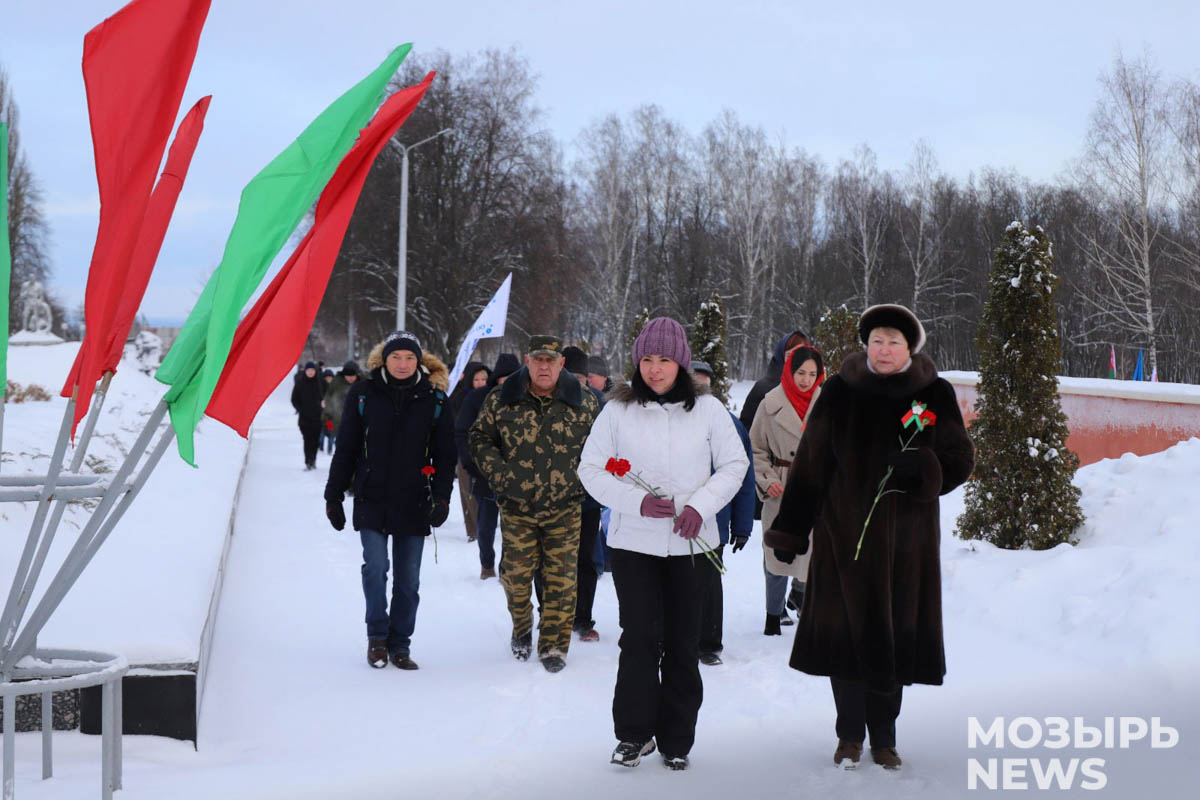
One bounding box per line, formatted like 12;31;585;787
302;305;974;770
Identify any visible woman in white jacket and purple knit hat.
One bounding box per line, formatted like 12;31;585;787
578;317;750;769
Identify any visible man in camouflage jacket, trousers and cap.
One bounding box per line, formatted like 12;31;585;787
469;336;599;672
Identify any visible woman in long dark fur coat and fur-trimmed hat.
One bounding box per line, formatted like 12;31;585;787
763;305;974;769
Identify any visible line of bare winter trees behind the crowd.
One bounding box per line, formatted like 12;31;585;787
313;50;1200;383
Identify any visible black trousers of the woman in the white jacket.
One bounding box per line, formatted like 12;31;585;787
612;548;710;756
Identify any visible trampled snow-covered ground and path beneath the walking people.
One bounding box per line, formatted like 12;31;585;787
0;375;1200;800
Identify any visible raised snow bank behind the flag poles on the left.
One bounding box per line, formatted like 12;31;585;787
0;342;246;663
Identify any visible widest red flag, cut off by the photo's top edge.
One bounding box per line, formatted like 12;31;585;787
62;0;211;434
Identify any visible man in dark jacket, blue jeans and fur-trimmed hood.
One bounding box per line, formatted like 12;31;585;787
325;331;455;669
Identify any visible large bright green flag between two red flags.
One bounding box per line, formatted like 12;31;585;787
155;44;412;465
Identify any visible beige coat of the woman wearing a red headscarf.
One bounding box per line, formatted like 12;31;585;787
750;385;821;581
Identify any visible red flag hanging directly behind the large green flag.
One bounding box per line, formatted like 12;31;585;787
206;72;434;437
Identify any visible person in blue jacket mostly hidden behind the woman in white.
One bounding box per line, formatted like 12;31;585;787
691;361;757;667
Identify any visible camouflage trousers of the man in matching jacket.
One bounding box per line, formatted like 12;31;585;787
500;503;580;658
